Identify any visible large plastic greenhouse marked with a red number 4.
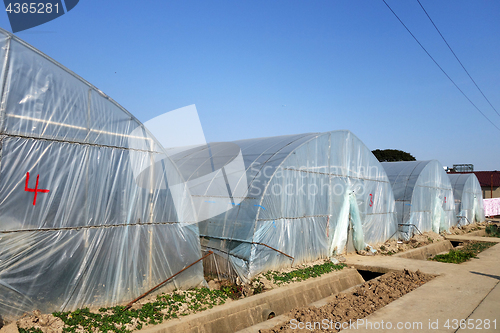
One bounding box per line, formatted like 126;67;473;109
0;30;204;320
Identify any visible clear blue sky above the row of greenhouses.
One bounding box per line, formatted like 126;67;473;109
0;0;500;170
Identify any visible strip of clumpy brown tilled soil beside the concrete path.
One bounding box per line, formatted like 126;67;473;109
260;270;434;333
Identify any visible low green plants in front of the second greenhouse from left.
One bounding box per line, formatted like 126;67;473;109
263;262;347;285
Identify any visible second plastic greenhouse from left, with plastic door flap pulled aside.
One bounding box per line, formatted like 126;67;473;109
172;131;397;281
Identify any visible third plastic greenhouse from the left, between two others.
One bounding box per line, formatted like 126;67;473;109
382;160;456;237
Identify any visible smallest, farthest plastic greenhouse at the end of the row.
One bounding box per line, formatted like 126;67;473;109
448;173;485;225
